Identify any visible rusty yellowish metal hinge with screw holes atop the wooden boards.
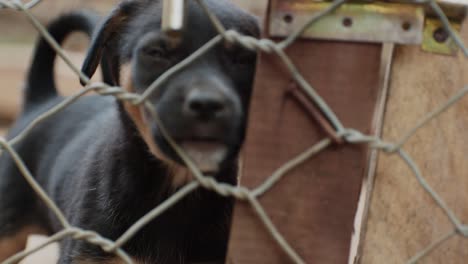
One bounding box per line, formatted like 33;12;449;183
269;0;468;54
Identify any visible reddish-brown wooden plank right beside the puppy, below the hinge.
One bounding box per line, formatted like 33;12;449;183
228;40;381;263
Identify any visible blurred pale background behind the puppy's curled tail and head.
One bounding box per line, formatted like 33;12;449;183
0;0;266;136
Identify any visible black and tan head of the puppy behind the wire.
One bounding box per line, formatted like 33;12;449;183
83;0;259;177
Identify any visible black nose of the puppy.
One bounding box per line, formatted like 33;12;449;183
185;89;226;119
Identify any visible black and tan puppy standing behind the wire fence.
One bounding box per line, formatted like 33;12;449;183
0;0;258;263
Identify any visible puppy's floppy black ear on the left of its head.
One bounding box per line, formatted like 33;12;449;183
81;0;142;85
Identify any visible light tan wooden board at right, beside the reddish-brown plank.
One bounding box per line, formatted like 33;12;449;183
360;22;468;264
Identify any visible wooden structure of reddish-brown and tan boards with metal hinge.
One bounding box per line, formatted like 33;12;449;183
227;0;468;264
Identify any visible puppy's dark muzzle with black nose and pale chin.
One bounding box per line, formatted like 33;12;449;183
154;76;243;173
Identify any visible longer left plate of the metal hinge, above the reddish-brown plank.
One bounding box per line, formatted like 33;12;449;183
269;0;424;44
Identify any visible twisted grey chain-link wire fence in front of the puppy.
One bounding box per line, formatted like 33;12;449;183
0;0;468;263
